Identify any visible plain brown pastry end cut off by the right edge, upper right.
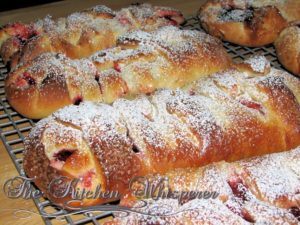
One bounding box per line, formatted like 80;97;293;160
274;25;300;76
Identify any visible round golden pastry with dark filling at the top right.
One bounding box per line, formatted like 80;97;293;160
198;0;300;47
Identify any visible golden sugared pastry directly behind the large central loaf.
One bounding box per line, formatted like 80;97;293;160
5;26;231;119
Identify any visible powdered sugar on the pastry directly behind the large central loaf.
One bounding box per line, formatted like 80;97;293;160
8;23;227;106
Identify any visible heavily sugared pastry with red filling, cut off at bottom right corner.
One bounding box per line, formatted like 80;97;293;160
105;147;300;225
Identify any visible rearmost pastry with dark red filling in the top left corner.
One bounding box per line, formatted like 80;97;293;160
0;5;114;67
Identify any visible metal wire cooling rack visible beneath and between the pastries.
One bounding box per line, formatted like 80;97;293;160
0;17;283;225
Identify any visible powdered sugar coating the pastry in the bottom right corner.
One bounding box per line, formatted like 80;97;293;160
109;148;300;224
